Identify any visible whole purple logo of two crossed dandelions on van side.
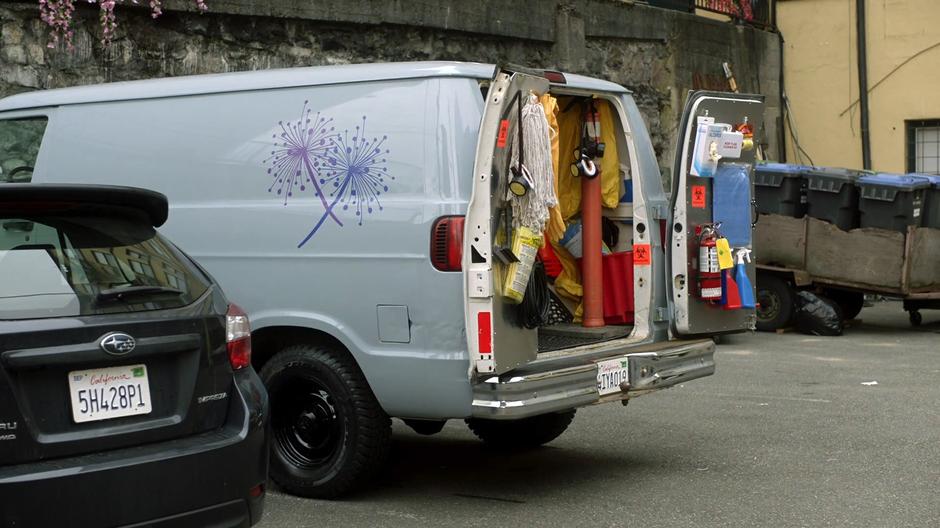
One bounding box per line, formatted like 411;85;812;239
264;105;395;248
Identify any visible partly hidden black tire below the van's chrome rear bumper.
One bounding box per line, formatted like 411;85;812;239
466;409;575;449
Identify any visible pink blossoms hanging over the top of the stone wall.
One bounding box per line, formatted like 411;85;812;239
39;0;209;50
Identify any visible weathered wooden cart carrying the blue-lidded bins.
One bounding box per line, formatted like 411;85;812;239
754;214;940;331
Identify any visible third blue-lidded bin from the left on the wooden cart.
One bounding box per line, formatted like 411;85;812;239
857;172;930;233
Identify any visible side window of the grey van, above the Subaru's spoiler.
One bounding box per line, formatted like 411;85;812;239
0;116;49;183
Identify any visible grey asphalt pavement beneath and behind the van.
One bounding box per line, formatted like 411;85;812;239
258;302;940;528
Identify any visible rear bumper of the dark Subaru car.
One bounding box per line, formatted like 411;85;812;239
0;369;268;528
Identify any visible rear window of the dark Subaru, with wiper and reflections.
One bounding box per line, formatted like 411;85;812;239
0;213;210;319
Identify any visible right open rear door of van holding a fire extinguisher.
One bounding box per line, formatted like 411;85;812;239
667;92;764;336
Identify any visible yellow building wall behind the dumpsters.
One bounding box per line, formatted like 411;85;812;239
777;0;940;172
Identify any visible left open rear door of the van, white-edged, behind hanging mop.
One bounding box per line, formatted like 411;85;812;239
463;68;549;374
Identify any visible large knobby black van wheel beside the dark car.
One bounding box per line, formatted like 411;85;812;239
261;345;392;499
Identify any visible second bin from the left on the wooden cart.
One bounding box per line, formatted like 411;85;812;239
803;167;867;231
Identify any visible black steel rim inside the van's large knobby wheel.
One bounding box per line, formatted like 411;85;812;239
269;374;346;470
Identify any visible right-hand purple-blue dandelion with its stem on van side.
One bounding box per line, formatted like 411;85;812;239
297;116;395;247
